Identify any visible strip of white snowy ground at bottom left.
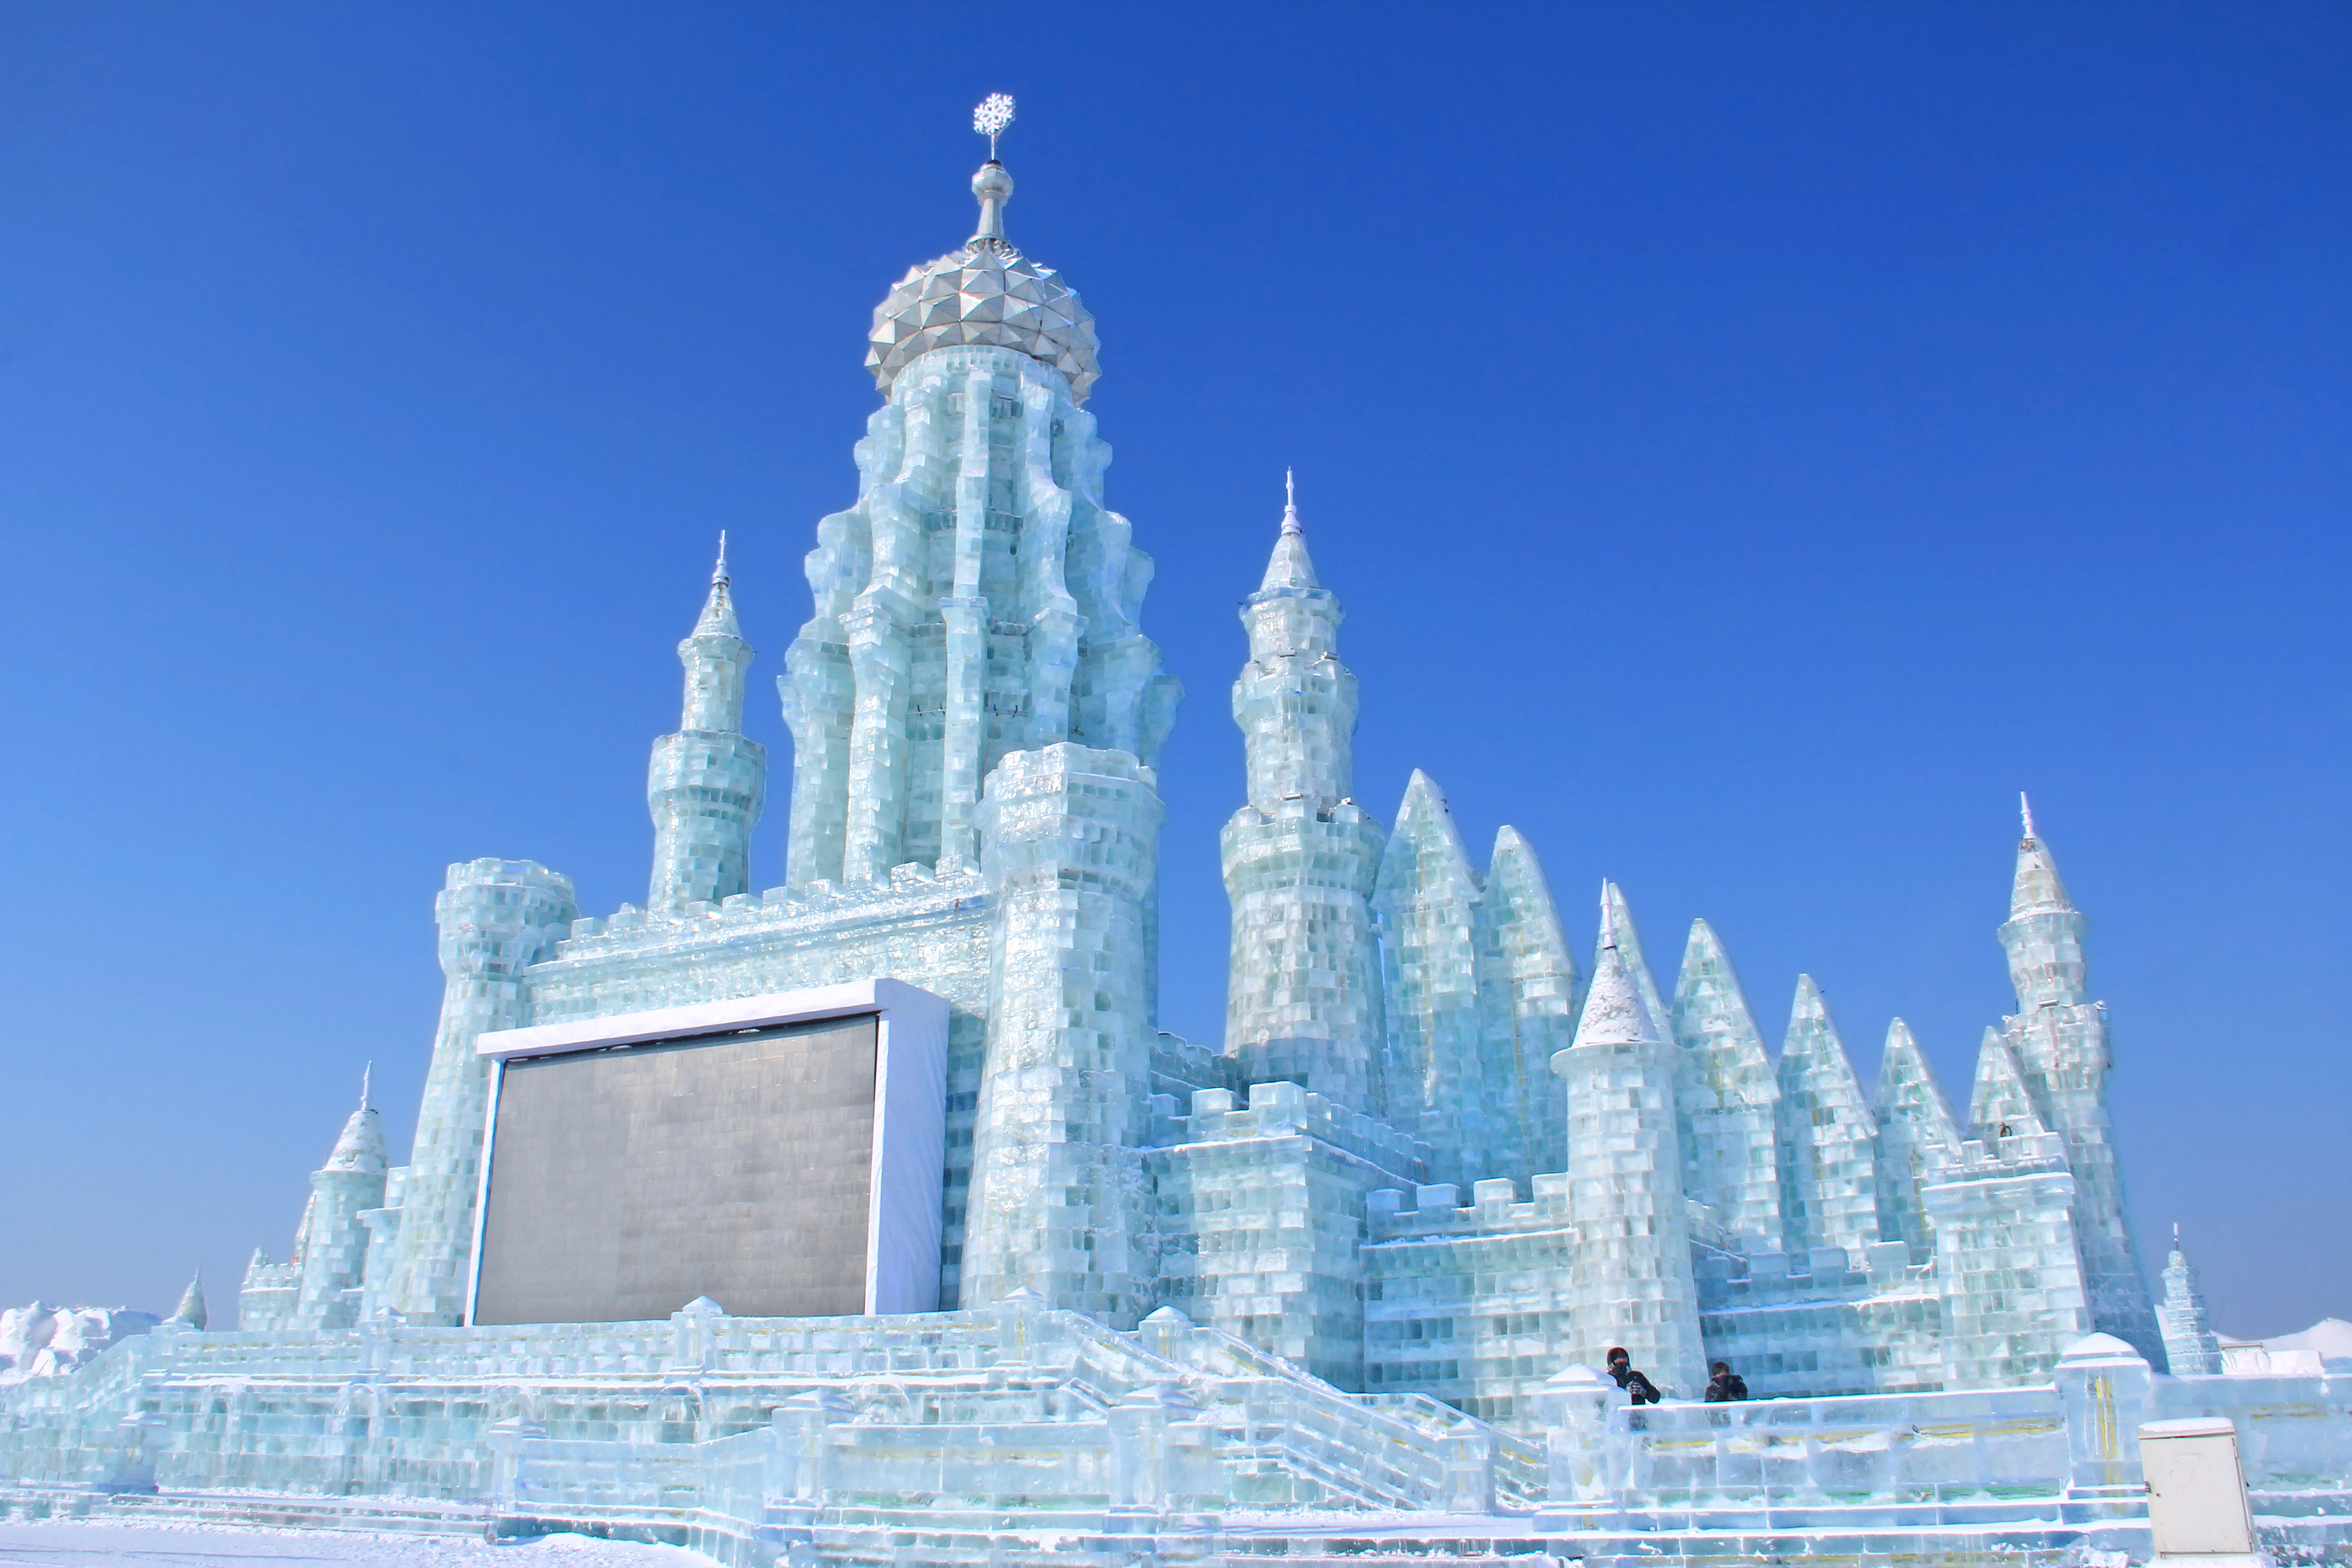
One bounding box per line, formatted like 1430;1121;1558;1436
0;1521;712;1568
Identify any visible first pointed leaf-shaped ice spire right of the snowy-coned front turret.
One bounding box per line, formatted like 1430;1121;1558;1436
1672;919;1780;1250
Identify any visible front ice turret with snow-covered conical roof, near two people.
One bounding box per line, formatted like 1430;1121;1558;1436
1553;893;1705;1398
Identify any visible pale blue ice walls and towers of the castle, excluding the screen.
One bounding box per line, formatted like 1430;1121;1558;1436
0;134;2343;1568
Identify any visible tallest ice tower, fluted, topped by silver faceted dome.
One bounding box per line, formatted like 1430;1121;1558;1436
779;134;1181;888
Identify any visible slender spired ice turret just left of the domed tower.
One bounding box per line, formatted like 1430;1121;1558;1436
644;538;767;910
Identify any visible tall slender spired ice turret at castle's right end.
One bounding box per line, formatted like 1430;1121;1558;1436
1999;816;2164;1370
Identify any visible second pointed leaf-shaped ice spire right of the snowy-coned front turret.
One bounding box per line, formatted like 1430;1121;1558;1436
1779;975;1879;1262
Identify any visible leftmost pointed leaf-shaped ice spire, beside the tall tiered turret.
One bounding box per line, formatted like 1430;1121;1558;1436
1371;769;1496;1182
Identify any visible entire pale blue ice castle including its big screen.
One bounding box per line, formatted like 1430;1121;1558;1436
0;103;2352;1563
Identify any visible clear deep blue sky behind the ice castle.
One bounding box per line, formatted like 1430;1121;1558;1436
0;0;2352;1336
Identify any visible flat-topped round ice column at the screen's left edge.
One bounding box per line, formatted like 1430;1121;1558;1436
386;860;579;1328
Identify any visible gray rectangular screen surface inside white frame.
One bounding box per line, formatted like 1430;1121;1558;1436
473;1015;875;1324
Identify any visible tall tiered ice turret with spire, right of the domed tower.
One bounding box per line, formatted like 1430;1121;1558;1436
1220;484;1383;1114
